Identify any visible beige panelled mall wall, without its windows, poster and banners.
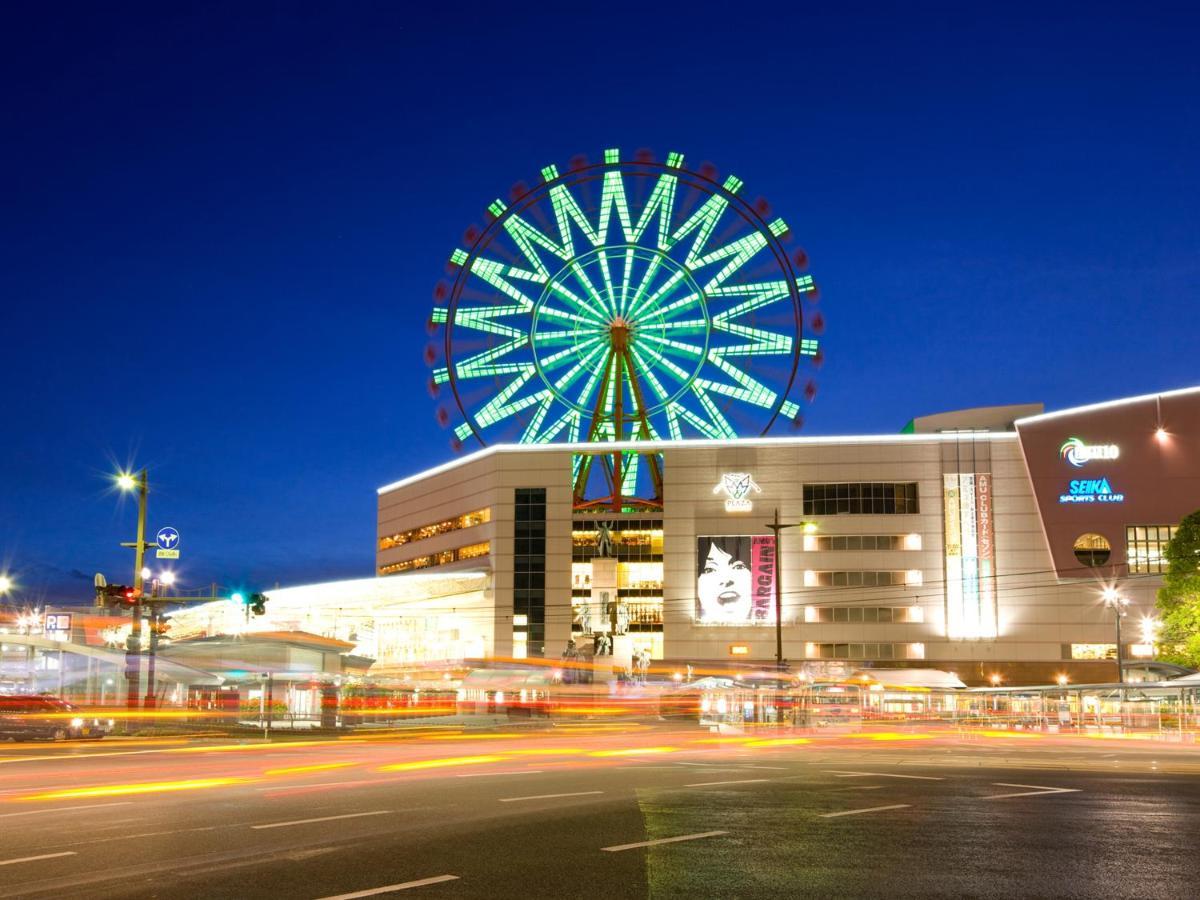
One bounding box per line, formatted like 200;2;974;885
377;432;1158;673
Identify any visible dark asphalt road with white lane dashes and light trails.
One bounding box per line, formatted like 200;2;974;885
0;725;1200;900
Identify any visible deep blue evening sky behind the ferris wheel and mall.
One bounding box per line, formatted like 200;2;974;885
0;2;1200;602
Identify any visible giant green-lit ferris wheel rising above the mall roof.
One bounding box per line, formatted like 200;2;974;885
426;150;823;508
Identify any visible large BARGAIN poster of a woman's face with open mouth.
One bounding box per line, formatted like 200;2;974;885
696;534;775;625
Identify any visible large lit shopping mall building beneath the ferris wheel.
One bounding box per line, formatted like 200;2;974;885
377;388;1200;684
